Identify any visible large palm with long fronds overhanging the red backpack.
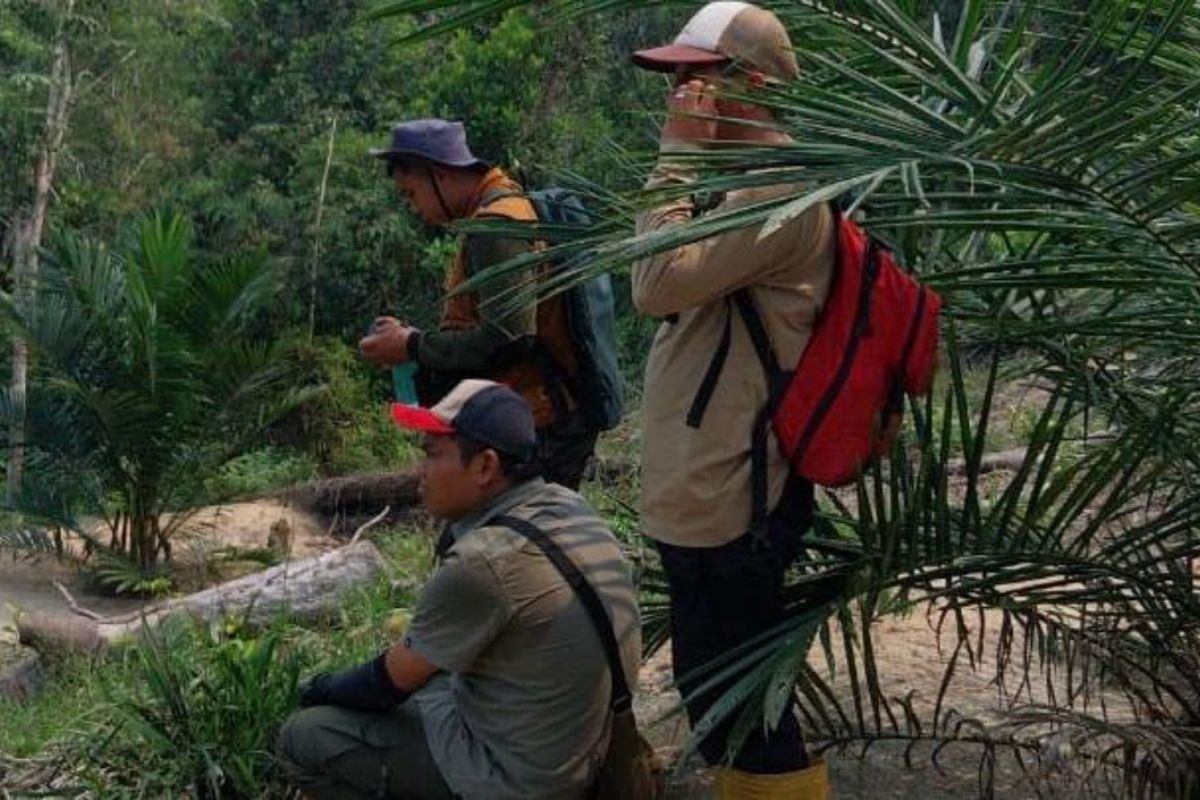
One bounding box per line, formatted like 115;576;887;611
382;0;1200;796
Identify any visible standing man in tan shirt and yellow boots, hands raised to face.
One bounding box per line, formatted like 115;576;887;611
632;2;835;800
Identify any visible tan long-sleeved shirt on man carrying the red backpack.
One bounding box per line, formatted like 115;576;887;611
634;152;835;547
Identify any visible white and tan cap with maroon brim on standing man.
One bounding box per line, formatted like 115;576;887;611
634;1;800;80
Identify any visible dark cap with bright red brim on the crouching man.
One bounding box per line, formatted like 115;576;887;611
391;380;538;462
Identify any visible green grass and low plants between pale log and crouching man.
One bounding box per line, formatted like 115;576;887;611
0;527;441;800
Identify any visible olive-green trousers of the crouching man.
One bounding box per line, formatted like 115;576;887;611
276;700;455;800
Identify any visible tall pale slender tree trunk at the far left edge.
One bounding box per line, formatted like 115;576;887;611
6;0;74;507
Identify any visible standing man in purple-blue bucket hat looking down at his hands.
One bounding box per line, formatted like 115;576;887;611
359;119;596;488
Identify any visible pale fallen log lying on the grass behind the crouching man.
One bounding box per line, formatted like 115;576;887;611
17;541;384;654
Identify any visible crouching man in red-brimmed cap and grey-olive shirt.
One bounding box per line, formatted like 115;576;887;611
278;380;641;800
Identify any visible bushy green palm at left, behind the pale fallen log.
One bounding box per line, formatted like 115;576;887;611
0;215;310;571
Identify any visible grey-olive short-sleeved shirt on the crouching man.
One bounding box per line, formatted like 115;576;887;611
407;479;641;800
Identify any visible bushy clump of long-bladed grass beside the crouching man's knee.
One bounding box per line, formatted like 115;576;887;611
80;622;306;799
